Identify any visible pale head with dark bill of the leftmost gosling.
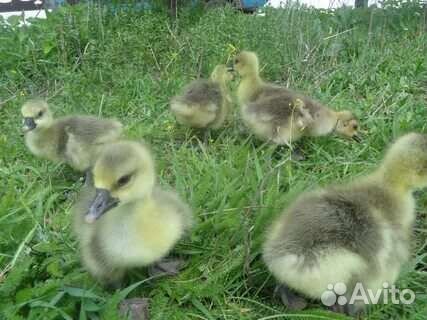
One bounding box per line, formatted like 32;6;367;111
21;99;53;132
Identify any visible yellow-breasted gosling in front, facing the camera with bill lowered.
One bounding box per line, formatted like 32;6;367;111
72;141;193;286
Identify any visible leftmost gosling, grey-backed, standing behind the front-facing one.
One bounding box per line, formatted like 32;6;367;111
21;99;122;171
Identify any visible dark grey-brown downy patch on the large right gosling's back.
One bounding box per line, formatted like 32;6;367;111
273;186;384;258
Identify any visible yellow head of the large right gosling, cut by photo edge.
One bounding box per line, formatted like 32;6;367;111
382;133;427;190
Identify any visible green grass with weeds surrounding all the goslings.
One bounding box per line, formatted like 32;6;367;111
0;5;427;320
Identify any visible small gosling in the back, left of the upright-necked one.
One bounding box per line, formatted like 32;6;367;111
170;64;233;129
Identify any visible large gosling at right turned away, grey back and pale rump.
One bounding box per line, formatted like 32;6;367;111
263;133;427;315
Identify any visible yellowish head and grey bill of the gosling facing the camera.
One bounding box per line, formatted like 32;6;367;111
85;141;155;223
